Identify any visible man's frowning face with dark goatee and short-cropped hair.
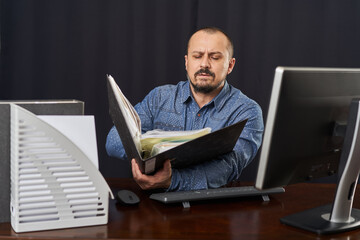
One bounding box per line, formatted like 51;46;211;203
185;31;235;93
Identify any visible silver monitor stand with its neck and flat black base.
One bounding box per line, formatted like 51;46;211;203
280;99;360;234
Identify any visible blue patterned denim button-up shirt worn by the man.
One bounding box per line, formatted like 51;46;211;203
106;81;264;191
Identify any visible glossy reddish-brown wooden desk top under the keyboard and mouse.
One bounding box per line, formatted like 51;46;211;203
0;179;360;240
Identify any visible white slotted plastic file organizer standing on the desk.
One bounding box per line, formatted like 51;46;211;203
11;104;113;232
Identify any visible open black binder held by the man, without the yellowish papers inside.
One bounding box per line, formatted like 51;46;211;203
107;75;247;174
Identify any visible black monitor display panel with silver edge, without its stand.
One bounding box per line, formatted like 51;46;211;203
255;67;360;189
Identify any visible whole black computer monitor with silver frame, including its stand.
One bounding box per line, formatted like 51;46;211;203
255;67;360;234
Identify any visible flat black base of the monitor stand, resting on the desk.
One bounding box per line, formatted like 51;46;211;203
280;204;360;234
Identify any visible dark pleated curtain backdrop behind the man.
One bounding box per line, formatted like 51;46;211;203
0;0;360;180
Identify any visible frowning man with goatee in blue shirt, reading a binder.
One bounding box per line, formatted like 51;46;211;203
106;27;264;191
